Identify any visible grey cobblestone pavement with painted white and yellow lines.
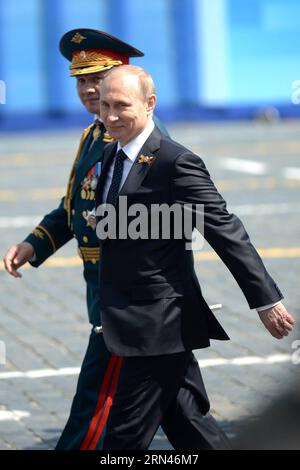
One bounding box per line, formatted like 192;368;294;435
0;122;300;449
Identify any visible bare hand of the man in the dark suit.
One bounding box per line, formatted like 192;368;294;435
259;302;295;339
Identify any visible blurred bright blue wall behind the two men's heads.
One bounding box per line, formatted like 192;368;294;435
0;0;300;129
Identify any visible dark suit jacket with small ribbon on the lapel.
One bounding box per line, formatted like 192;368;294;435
96;128;282;356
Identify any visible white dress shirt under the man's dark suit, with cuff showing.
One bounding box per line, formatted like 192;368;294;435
103;119;281;313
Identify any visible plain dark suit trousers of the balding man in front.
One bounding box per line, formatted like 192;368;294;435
103;352;230;450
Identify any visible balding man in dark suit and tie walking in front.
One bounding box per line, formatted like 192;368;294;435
96;66;294;450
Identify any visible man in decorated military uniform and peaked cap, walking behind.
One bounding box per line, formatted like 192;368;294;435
4;29;228;450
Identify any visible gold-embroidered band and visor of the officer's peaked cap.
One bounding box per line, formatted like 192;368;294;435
70;51;123;77
